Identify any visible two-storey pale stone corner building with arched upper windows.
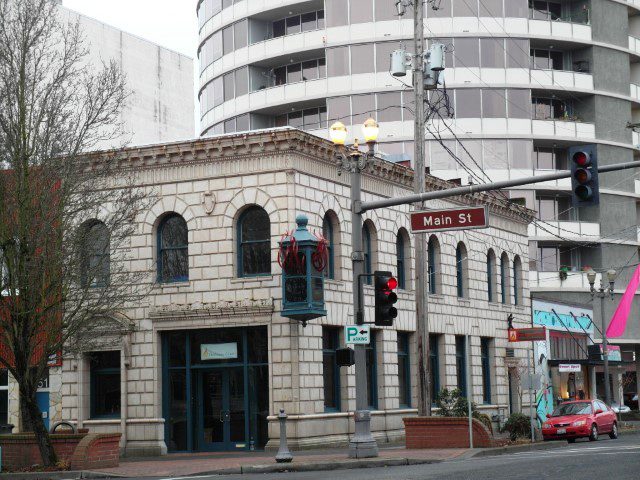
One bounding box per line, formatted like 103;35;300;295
13;128;531;455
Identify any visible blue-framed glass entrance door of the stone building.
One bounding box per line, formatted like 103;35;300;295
198;368;247;451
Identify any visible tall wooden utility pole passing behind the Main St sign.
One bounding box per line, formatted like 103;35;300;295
413;0;432;417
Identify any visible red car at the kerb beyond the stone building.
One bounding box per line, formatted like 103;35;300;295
542;400;618;443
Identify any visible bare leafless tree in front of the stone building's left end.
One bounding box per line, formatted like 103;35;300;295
0;0;145;465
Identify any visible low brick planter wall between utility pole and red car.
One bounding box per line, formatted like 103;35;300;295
403;417;495;448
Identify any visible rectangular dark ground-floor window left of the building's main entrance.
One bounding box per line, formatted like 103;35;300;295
89;350;120;418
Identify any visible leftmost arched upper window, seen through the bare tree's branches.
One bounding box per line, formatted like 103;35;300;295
80;220;110;288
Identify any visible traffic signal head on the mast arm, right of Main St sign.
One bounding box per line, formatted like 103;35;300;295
569;145;600;207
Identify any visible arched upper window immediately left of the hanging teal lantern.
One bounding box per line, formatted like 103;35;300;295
238;206;271;277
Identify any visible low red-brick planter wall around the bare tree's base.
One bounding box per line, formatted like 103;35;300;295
0;433;120;470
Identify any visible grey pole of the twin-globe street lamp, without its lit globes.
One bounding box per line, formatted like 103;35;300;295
343;144;378;458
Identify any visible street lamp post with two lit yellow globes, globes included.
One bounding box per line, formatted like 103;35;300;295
329;118;379;458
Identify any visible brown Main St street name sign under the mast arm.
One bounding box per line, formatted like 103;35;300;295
411;206;489;233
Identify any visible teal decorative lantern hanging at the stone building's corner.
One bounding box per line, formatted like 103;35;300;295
278;215;328;327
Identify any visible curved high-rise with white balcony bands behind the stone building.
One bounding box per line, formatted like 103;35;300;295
198;0;640;404
